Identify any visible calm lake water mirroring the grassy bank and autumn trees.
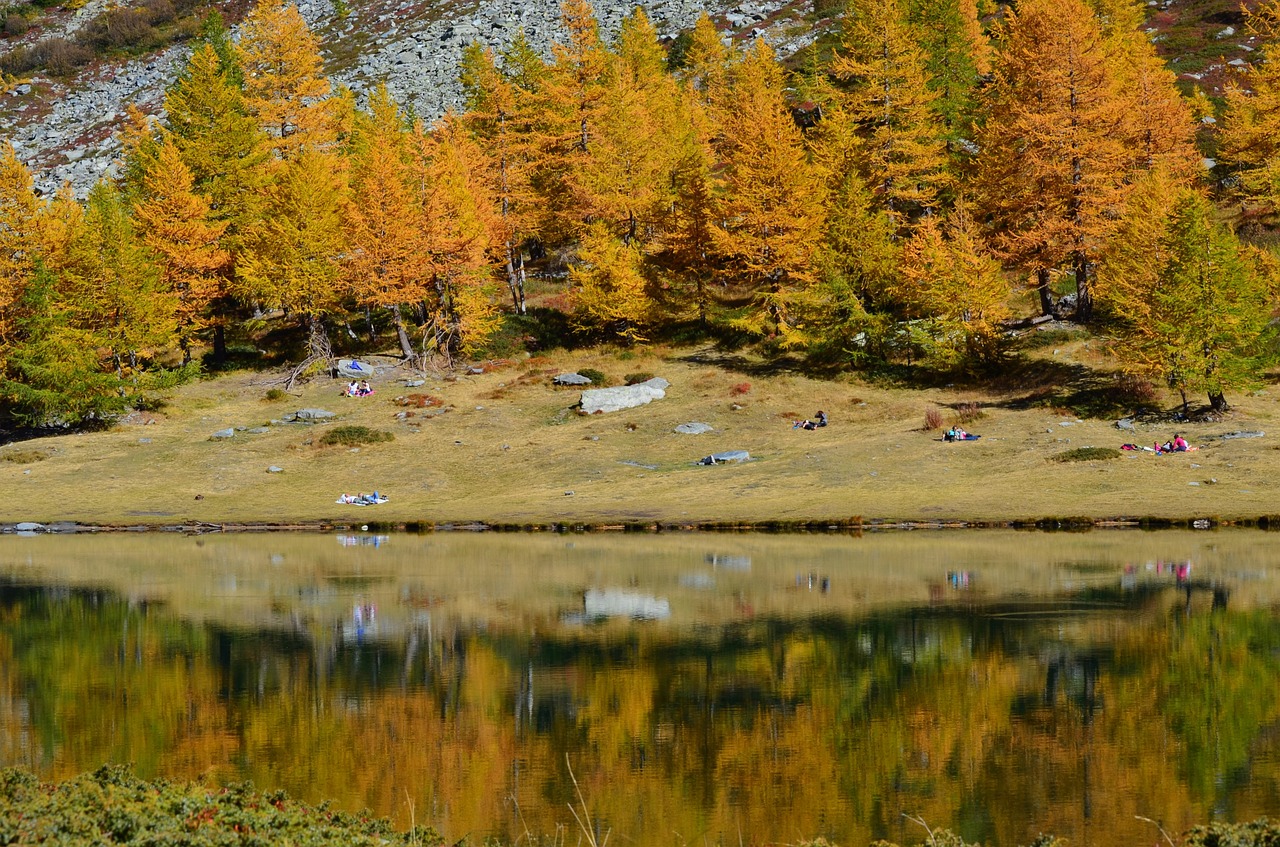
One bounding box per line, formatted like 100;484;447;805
0;531;1280;847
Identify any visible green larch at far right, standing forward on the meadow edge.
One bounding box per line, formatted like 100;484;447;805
1117;189;1276;412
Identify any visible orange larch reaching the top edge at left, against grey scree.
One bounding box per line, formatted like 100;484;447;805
236;0;338;159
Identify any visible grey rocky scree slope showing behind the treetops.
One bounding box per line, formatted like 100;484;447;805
0;0;814;194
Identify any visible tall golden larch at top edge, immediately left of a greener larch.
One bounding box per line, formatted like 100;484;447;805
831;0;951;226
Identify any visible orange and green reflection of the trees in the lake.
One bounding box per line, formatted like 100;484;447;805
0;547;1280;844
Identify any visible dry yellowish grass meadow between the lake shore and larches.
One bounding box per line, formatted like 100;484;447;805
0;351;1280;523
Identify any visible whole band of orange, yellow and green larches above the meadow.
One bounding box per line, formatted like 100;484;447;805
0;0;1280;420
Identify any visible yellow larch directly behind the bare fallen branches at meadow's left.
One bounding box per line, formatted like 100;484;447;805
236;148;347;374
